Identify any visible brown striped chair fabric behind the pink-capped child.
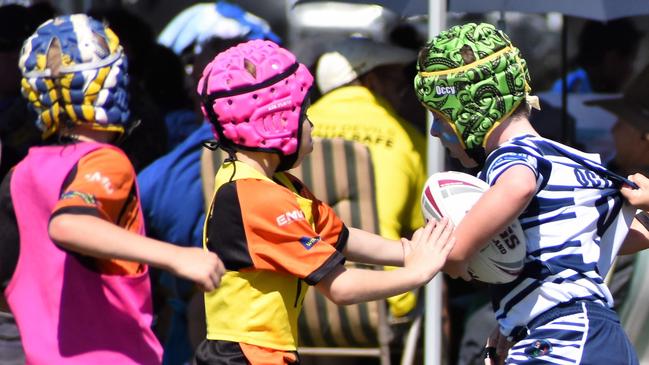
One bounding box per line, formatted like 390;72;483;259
201;138;389;350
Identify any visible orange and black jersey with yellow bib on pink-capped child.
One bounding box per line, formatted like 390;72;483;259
204;161;348;351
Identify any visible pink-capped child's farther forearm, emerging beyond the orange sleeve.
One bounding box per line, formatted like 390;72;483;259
343;227;405;266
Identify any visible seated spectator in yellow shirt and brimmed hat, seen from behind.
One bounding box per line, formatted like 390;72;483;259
309;38;426;317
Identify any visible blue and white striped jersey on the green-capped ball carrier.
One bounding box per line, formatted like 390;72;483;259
479;135;635;335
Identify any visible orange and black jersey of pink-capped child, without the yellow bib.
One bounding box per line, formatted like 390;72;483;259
206;168;347;285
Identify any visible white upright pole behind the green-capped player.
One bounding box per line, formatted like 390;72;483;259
424;0;446;365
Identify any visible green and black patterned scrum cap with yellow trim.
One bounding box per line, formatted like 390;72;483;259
415;23;531;159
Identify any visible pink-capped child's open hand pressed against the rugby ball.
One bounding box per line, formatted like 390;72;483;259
401;218;455;282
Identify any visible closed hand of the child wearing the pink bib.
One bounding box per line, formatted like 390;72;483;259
171;247;225;292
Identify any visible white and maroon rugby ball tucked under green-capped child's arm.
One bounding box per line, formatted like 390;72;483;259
421;171;526;284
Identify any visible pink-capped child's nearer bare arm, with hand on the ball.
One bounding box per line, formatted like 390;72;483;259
316;219;455;305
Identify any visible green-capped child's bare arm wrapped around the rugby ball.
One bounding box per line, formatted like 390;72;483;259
444;165;536;278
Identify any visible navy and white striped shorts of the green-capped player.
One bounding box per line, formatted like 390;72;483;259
506;301;638;365
